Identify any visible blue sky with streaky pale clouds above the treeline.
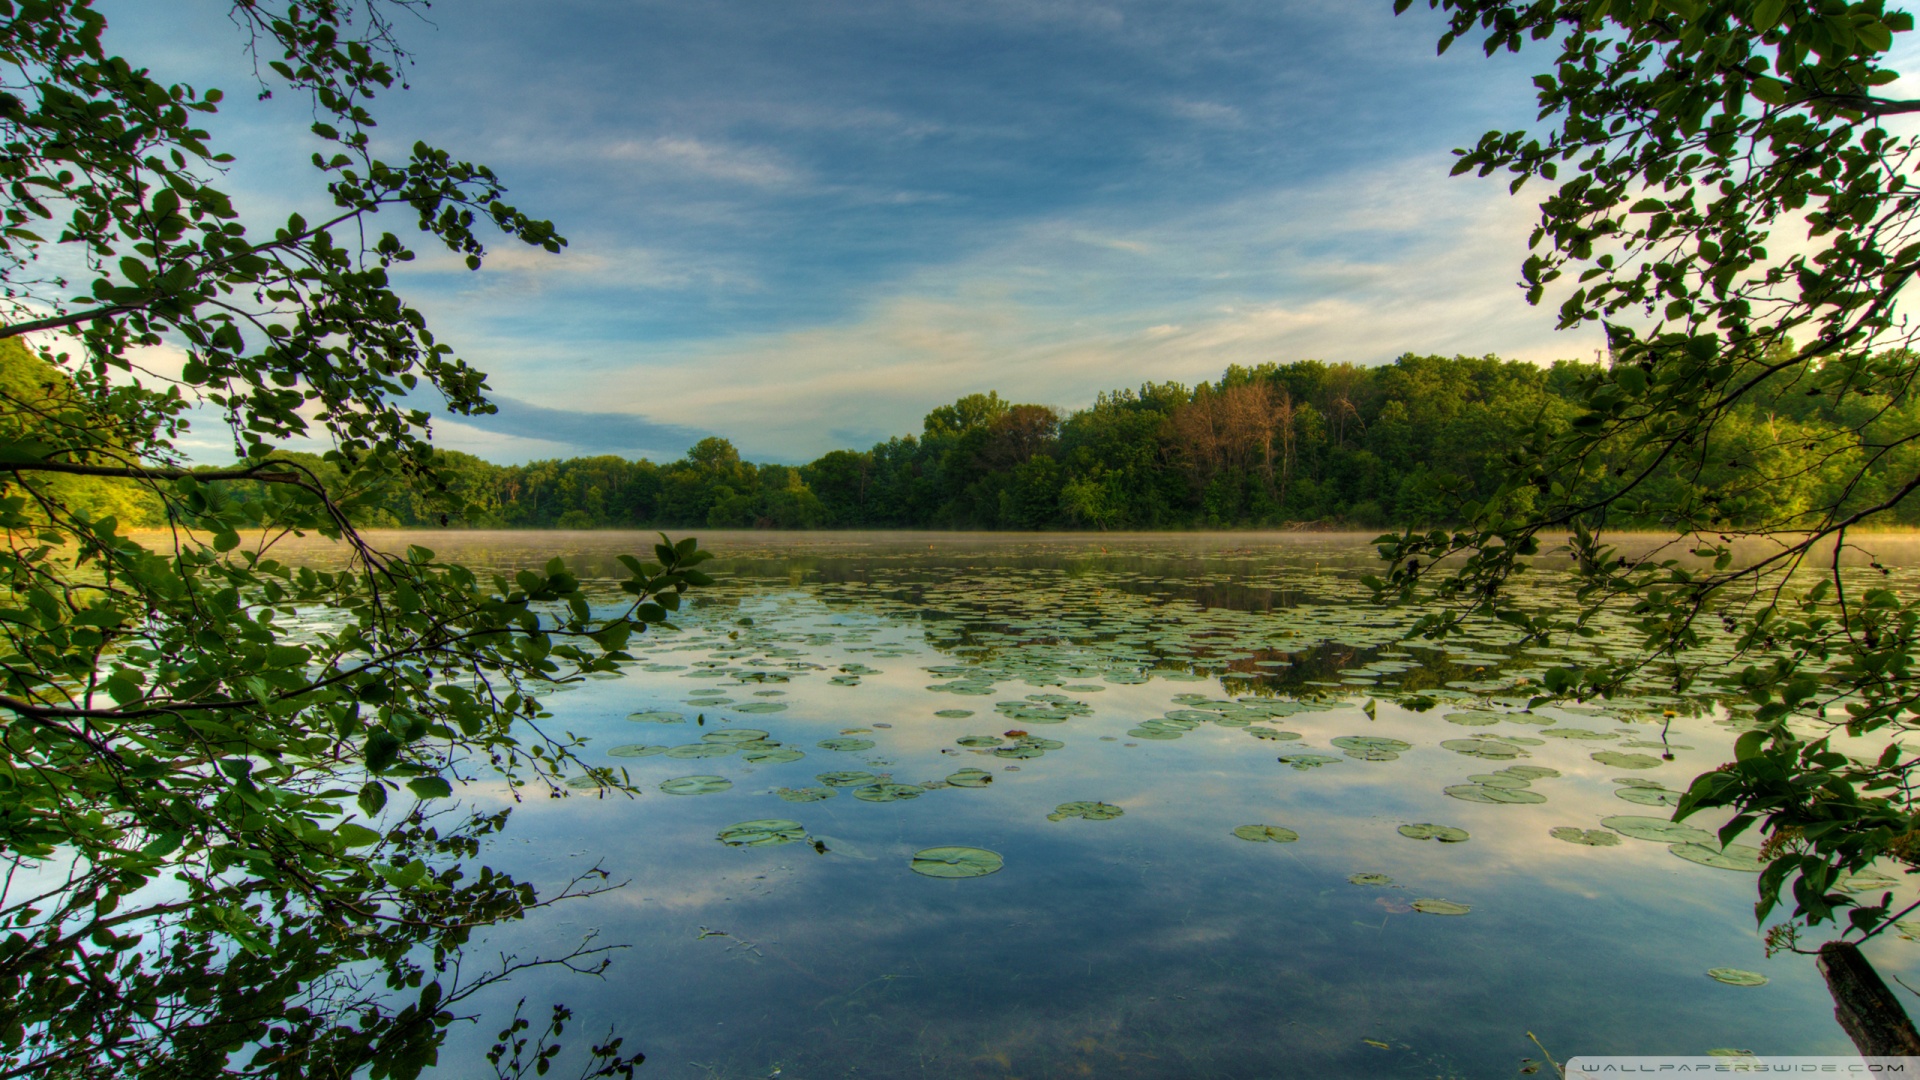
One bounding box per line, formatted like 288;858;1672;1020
102;0;1601;463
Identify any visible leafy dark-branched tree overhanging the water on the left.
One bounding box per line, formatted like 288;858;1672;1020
0;0;705;1078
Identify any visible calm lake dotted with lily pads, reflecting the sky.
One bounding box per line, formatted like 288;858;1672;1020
295;532;1920;1080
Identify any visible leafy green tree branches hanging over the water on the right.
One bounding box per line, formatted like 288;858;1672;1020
1380;0;1920;1037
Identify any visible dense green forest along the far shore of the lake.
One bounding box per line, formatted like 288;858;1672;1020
26;350;1920;530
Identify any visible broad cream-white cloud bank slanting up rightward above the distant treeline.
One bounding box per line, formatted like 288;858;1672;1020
503;151;1599;457
